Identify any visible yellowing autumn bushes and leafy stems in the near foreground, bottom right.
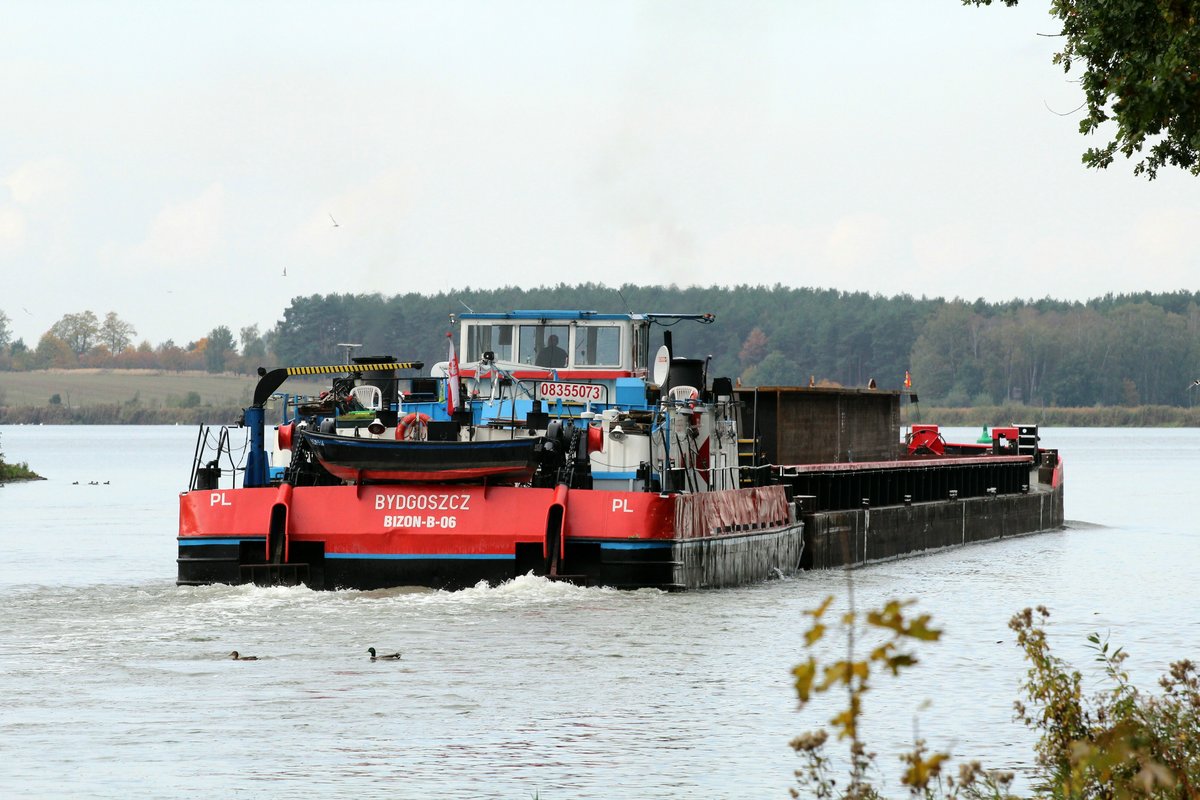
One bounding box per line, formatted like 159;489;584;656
791;596;1200;800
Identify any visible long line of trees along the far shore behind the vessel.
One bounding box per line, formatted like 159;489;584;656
0;283;1200;408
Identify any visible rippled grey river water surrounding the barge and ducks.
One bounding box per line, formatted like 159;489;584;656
0;426;1200;800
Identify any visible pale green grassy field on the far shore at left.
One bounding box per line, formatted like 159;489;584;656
0;369;329;408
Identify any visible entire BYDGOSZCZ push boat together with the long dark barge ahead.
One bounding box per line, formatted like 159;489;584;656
176;311;1062;590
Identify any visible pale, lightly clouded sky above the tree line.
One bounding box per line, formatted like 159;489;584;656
0;0;1200;345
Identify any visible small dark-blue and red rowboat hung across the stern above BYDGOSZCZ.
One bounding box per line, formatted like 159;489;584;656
298;429;542;483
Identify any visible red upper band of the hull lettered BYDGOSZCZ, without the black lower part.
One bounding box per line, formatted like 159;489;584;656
179;485;790;554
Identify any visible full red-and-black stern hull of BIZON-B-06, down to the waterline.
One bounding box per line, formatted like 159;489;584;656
178;483;804;590
